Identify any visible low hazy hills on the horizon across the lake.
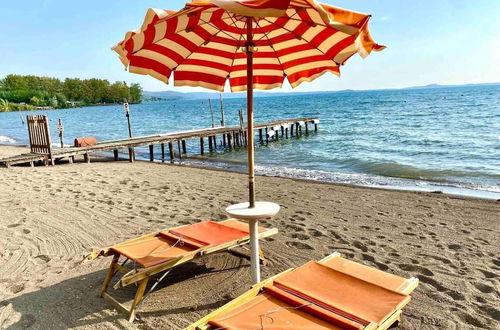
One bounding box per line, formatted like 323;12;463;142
142;82;500;100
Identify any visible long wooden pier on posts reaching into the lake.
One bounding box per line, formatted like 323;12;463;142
0;118;319;167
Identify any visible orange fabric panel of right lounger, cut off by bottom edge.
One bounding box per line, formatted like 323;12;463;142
209;293;342;330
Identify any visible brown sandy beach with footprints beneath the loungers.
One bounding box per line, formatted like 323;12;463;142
0;146;500;329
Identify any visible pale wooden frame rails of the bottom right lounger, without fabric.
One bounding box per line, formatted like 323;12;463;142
184;252;419;330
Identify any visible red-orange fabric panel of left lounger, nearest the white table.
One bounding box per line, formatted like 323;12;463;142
169;221;248;245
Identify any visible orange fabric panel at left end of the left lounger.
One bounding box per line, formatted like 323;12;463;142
112;236;193;267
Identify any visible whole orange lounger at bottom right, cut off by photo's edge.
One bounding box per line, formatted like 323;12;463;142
186;253;418;330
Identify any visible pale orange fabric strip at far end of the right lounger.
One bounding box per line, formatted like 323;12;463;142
321;257;408;293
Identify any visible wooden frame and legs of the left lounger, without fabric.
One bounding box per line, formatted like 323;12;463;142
83;219;278;322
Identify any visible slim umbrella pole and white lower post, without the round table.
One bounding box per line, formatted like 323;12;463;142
246;17;260;283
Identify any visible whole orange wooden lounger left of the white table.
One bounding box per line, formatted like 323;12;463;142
83;219;278;322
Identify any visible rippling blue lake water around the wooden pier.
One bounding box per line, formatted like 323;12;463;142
0;85;500;199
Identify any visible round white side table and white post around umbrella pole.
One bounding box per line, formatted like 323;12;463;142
226;202;280;284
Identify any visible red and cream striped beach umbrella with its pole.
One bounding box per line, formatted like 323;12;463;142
113;0;384;280
